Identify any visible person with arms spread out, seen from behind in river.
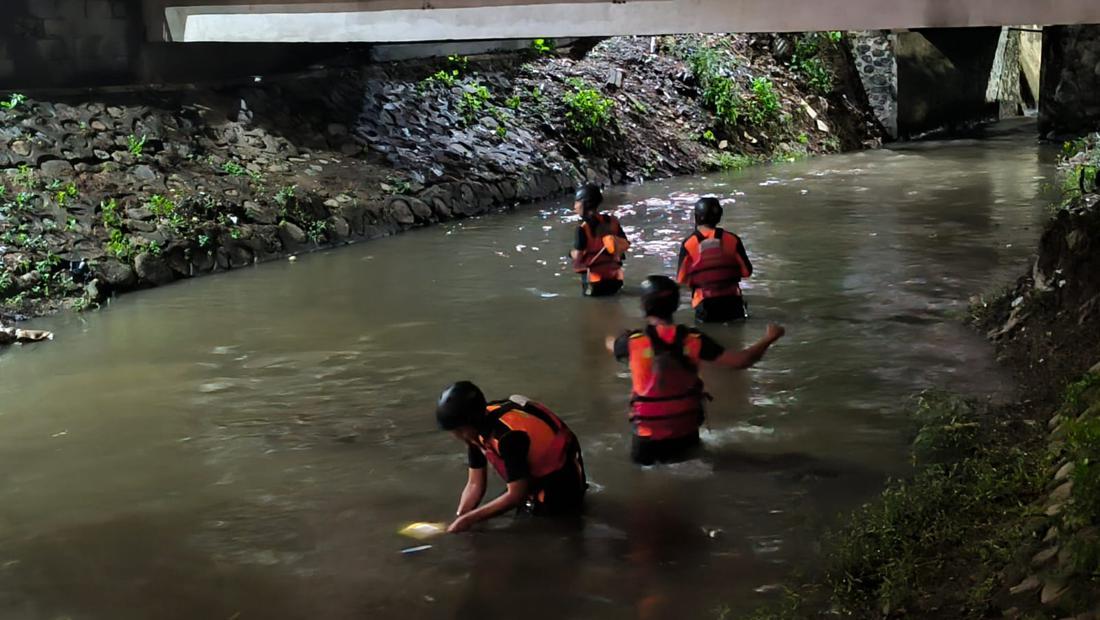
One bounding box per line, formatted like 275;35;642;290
607;276;784;465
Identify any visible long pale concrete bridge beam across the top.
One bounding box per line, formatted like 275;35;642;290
157;0;1100;43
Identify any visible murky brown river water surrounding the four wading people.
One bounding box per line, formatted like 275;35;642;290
0;123;1054;620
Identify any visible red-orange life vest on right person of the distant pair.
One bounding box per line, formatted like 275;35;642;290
678;229;750;307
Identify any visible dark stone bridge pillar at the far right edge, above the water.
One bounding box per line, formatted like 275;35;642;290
1040;24;1100;137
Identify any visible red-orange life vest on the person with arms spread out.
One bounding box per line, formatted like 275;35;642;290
628;325;706;440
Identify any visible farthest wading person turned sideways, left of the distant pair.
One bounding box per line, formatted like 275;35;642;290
569;184;630;297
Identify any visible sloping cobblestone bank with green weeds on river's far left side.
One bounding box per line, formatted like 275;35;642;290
0;35;881;329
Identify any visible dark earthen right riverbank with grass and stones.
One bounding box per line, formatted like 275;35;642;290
743;136;1100;620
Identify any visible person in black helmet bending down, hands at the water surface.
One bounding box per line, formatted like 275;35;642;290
436;381;589;532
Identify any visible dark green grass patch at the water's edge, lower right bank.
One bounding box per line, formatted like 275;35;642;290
755;394;1048;619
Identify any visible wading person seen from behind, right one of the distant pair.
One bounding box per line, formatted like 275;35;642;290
677;198;752;323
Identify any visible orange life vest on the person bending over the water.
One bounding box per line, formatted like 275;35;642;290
482;400;575;478
